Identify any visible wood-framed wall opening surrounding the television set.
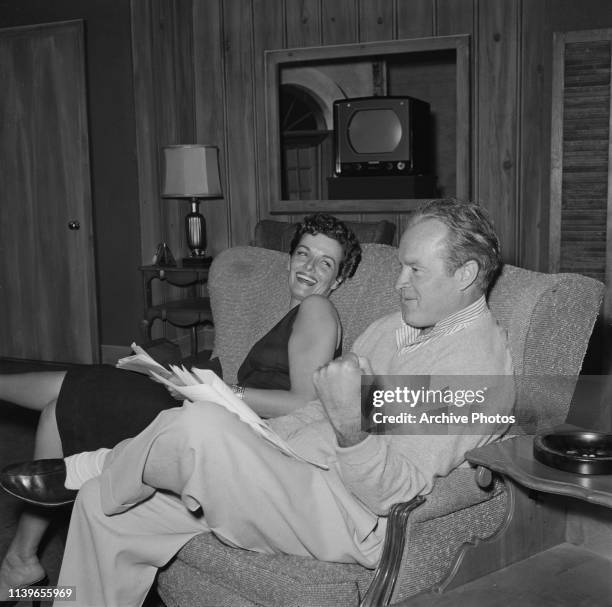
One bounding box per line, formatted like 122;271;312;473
266;36;470;214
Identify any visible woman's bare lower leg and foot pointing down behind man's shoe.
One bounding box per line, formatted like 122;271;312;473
0;400;63;601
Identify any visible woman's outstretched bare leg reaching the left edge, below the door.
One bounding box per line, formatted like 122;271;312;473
0;371;66;411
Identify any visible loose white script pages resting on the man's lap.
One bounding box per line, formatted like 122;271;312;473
116;344;328;470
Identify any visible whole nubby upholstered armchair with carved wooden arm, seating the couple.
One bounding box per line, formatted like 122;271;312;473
158;244;603;607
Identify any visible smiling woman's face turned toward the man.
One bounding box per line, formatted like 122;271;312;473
289;234;343;301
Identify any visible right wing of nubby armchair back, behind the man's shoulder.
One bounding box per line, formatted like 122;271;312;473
489;265;604;433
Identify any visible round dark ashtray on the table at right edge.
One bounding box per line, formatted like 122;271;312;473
533;430;612;474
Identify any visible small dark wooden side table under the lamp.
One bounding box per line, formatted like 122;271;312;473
139;265;213;356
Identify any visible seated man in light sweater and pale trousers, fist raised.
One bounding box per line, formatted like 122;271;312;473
58;200;514;605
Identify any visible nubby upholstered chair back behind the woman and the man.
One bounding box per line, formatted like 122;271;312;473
209;244;603;431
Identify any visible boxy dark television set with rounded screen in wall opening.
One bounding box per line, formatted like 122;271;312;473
333;96;432;177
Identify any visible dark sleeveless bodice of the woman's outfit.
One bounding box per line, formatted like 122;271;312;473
238;306;342;390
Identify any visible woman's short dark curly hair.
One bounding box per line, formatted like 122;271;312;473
289;213;361;280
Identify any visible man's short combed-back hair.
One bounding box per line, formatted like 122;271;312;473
409;198;502;293
